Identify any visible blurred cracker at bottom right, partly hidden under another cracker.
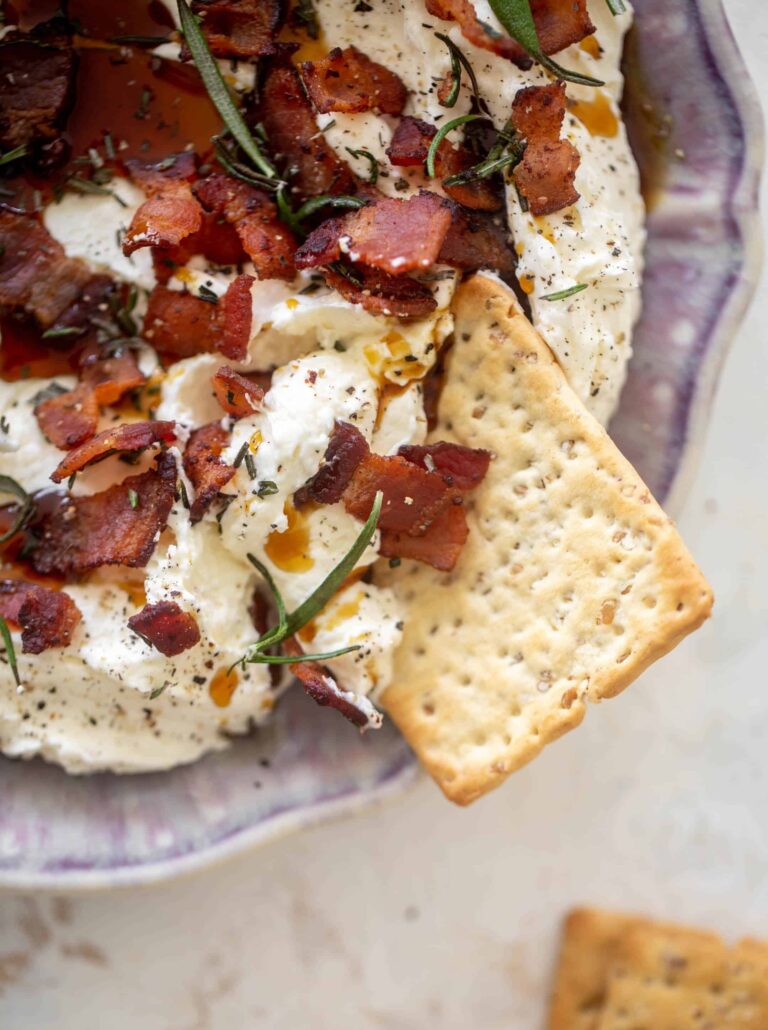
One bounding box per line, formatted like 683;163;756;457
547;908;637;1030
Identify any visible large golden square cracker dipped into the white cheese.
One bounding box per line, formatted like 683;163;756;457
379;275;712;804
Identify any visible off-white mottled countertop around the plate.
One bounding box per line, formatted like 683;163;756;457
0;0;768;1030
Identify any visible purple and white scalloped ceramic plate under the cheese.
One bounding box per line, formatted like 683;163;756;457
0;0;762;890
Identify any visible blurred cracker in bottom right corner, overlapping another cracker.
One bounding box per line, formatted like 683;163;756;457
595;920;768;1030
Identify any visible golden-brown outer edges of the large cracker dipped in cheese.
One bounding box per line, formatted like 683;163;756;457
381;274;713;805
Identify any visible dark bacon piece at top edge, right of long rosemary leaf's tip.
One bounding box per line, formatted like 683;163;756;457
184;0;286;59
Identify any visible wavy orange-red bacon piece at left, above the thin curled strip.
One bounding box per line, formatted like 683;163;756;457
35;351;145;450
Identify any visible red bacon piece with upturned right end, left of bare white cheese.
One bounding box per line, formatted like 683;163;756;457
144;273;253;361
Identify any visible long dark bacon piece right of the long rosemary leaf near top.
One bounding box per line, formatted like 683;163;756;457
259;65;355;199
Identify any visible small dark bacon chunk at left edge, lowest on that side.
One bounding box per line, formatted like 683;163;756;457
0;580;82;654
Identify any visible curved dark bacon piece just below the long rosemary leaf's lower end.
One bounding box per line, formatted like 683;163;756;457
195;175;296;282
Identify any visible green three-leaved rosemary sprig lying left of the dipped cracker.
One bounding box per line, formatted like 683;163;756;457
232;490;384;668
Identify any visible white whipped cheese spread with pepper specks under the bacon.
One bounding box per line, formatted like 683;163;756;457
0;0;643;773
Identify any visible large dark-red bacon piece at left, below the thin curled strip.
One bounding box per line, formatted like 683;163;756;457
29;451;176;577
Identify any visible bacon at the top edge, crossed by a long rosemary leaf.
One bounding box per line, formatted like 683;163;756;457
426;0;595;68
